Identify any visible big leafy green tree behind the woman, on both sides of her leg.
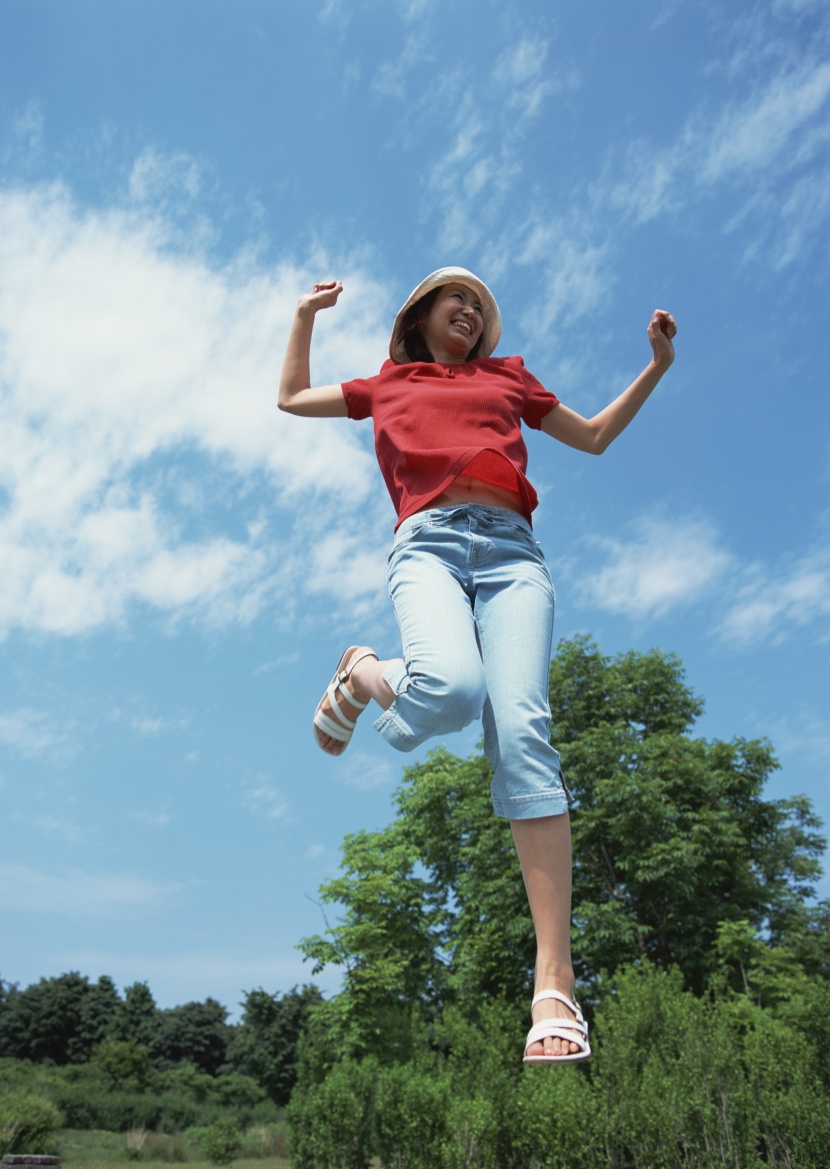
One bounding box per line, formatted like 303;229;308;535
300;639;828;1060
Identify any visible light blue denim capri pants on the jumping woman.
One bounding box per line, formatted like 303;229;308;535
374;504;568;819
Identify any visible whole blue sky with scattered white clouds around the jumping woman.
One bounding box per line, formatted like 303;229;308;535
0;0;830;1012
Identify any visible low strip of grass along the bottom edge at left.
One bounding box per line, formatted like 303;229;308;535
58;1129;291;1169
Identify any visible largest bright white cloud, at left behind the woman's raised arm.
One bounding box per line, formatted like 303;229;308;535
0;175;389;636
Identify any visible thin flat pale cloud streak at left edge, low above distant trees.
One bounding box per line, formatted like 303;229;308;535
0;863;181;916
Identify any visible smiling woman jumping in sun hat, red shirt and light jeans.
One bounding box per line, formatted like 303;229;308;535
279;268;677;1063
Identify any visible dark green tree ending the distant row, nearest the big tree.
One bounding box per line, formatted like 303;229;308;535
228;985;323;1106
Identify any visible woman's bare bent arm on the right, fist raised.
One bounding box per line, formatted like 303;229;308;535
541;309;677;455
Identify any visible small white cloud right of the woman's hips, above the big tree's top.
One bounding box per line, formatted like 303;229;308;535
582;518;732;620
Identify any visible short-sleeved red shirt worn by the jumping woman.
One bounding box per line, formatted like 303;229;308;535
343;357;559;526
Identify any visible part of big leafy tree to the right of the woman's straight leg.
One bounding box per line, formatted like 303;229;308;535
551;639;825;991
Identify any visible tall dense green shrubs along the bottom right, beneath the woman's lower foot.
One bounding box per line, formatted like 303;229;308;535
289;967;830;1169
